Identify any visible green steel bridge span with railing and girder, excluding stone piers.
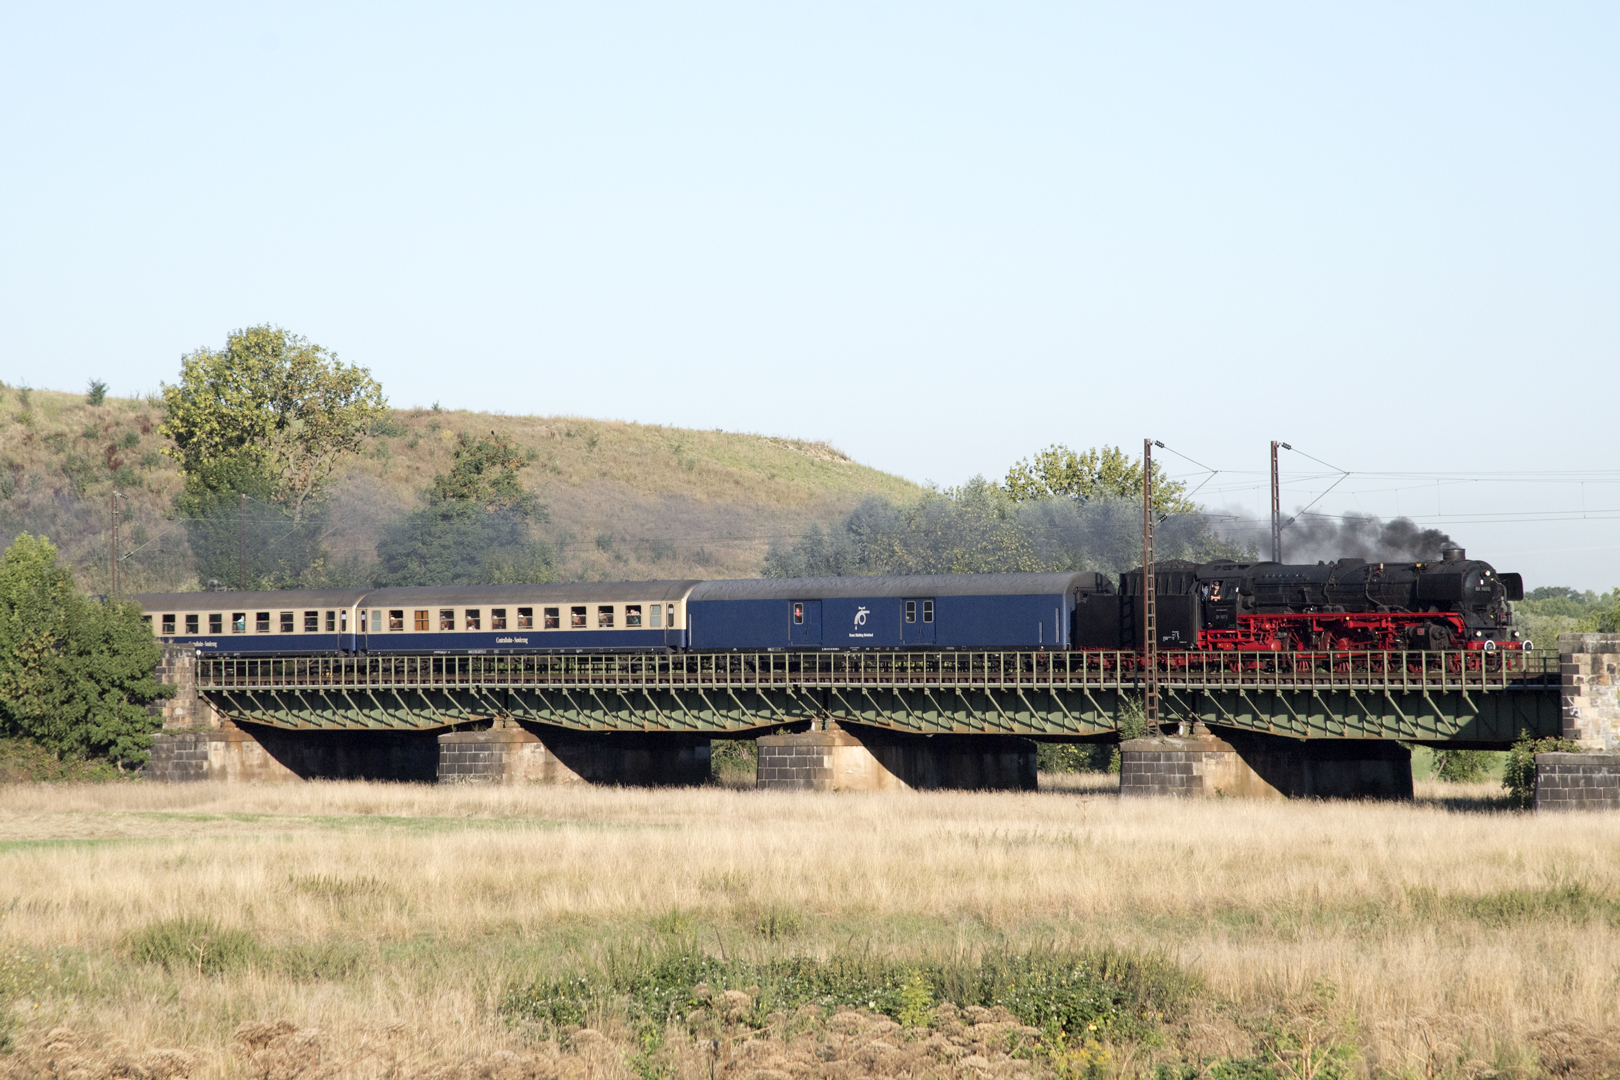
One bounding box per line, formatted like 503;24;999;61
196;651;1560;745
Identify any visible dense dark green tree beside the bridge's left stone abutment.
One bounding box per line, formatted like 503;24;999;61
0;533;172;769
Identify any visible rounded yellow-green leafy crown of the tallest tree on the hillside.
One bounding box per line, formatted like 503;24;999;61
159;325;387;523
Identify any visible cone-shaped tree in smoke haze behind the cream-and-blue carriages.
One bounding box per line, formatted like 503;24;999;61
377;432;557;585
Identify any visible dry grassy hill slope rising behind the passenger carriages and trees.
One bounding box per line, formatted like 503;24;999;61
0;387;922;591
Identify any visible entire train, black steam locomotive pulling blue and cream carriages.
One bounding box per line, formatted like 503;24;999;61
134;547;1531;656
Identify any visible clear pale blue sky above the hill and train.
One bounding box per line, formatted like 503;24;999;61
0;2;1620;588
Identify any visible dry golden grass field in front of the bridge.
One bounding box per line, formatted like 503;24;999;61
0;779;1620;1080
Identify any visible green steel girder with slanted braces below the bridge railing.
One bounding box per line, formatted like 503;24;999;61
204;687;1562;745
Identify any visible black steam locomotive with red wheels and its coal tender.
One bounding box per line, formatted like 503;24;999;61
1074;547;1531;653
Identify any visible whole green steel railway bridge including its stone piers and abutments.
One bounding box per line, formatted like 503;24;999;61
142;635;1620;795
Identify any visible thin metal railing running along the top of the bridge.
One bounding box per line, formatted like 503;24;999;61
198;651;1560;693
